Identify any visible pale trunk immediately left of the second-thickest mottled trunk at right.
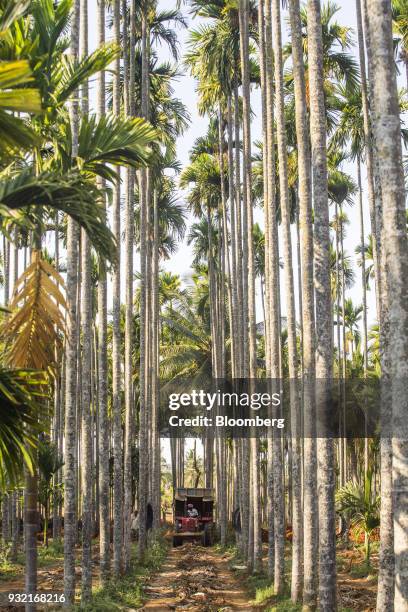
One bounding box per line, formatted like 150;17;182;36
289;0;317;606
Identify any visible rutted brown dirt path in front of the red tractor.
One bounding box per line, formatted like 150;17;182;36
141;544;259;612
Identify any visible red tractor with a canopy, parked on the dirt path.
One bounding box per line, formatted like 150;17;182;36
173;488;214;546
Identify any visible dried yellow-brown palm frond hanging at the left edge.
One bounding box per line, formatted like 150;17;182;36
0;251;66;370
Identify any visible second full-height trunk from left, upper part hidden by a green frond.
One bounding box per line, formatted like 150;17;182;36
80;0;92;603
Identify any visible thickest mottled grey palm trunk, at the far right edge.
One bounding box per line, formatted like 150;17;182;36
367;0;408;612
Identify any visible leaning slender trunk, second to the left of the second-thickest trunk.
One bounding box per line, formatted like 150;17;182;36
272;0;303;602
